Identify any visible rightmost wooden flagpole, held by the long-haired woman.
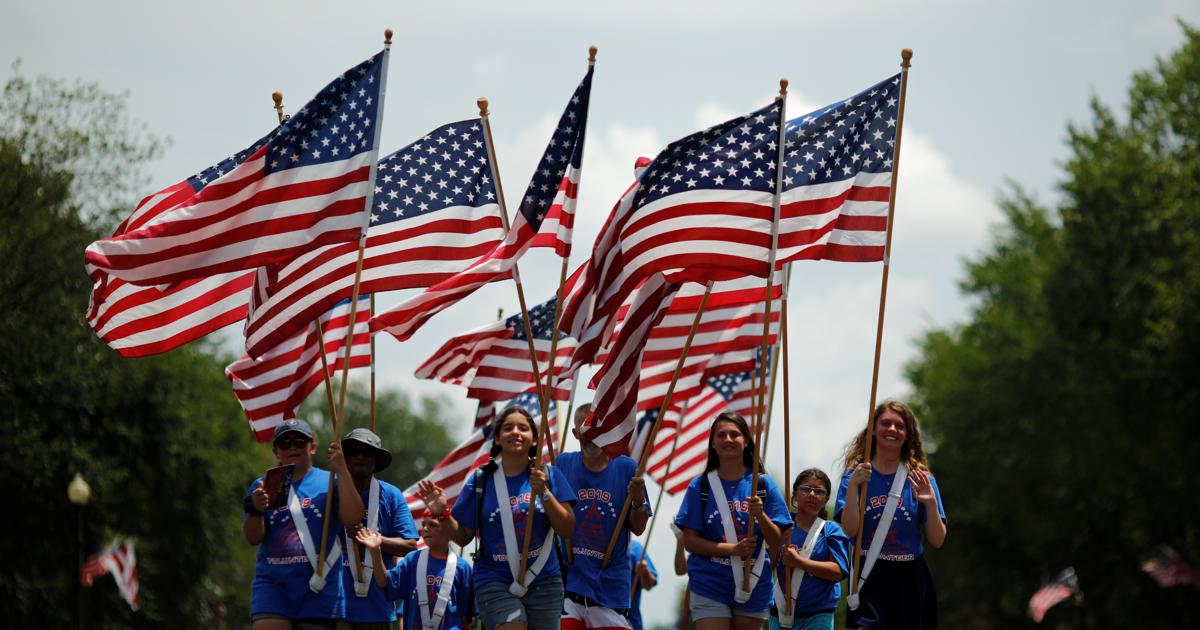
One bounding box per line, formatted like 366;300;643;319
850;48;912;596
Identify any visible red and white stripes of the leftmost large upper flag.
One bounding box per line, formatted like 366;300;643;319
84;145;376;286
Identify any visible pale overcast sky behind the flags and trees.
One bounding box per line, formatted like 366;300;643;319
0;0;1200;624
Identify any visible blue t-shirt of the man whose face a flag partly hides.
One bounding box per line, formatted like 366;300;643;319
558;452;649;608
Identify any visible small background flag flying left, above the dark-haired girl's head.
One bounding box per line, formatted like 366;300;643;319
415;298;575;401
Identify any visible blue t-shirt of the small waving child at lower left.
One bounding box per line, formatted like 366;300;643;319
386;551;472;630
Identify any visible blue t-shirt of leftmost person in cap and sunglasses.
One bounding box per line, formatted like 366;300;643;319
242;467;344;619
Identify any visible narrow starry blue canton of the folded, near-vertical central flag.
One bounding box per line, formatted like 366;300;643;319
520;68;592;232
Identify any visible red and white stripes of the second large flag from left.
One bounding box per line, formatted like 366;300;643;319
246;196;504;356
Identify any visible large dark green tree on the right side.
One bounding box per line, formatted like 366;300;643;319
908;26;1200;628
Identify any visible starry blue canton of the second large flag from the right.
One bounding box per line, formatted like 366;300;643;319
634;101;780;208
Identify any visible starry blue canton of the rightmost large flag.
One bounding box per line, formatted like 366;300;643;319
784;74;900;190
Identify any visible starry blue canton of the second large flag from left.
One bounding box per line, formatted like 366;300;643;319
371;119;496;226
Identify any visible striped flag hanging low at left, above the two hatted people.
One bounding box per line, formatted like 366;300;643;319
226;295;371;442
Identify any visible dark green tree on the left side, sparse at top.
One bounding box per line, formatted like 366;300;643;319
0;66;269;628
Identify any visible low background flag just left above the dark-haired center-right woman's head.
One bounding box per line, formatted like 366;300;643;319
646;353;762;494
